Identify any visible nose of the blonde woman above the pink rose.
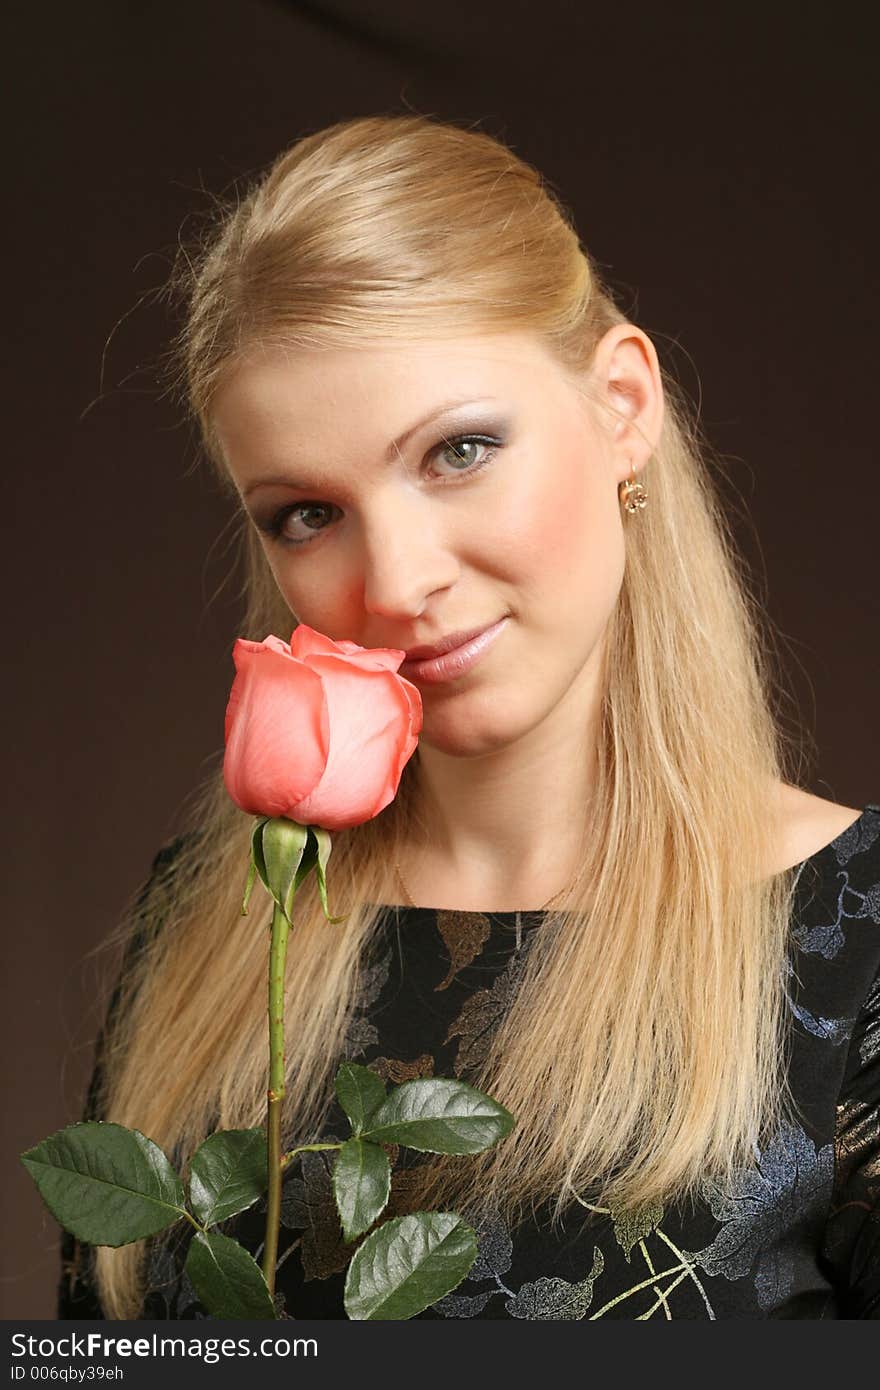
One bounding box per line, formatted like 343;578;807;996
363;496;459;619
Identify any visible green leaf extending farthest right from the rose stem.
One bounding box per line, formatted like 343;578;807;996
361;1077;513;1154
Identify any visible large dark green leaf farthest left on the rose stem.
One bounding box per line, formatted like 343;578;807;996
21;1120;186;1245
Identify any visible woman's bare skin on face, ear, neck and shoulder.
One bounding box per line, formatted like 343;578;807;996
211;324;861;912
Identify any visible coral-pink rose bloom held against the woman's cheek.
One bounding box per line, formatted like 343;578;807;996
222;623;421;830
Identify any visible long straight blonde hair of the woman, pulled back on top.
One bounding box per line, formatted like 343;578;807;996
88;114;811;1318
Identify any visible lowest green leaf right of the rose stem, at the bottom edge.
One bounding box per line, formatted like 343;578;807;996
345;1212;477;1322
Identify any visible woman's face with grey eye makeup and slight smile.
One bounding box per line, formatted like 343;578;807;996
211;325;656;755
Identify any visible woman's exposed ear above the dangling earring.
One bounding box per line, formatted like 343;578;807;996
589;324;663;482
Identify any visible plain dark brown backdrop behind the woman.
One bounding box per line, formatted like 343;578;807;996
3;0;880;1319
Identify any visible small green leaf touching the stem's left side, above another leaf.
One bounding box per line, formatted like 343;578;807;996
189;1129;268;1226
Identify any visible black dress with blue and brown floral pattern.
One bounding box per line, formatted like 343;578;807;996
58;803;880;1321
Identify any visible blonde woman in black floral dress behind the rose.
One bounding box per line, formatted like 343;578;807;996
60;115;880;1319
